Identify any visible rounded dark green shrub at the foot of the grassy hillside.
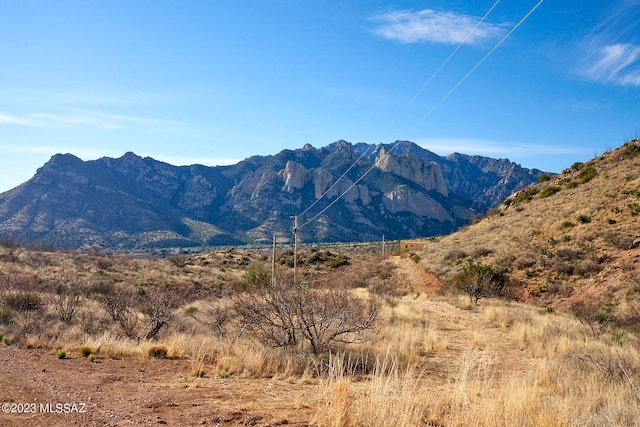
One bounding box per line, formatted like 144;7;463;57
455;261;508;303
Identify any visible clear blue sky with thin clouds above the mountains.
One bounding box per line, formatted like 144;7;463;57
0;0;640;191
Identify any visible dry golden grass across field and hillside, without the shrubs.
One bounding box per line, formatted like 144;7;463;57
0;142;640;427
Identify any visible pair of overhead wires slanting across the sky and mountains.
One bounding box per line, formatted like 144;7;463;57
298;0;544;230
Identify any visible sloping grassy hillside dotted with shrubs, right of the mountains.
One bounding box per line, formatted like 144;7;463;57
420;140;640;308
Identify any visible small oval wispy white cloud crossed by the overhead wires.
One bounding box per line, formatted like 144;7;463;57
371;9;506;45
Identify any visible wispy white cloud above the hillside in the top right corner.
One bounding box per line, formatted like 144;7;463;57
580;0;640;86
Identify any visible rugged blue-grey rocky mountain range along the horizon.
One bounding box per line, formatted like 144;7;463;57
0;141;542;250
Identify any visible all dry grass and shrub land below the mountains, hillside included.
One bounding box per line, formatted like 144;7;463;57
0;142;640;426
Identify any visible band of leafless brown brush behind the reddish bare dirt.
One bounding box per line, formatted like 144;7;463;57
0;247;389;354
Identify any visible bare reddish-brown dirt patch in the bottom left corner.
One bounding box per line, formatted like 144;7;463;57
0;345;318;426
